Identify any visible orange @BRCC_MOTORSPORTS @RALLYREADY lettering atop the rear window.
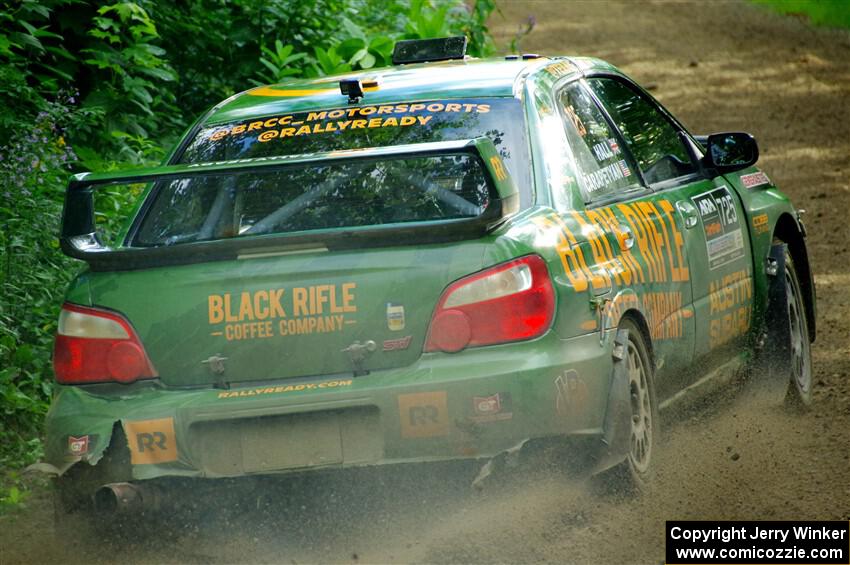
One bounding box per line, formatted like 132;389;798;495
209;102;490;143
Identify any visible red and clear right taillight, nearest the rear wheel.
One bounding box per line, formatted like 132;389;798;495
425;255;555;352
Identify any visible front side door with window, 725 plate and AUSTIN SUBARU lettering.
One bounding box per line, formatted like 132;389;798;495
587;76;753;376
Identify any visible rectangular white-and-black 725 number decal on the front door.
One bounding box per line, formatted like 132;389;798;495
692;186;745;270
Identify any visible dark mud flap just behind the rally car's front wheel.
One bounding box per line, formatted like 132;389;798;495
754;243;791;392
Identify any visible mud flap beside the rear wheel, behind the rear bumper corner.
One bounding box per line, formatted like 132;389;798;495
592;330;632;473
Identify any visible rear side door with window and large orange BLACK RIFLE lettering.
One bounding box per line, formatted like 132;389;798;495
556;81;695;397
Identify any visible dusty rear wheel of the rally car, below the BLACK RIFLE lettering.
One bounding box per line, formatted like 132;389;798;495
600;318;660;494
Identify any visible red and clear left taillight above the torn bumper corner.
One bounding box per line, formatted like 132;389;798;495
53;303;157;384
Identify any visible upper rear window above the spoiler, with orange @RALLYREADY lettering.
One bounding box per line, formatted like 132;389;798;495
180;98;530;198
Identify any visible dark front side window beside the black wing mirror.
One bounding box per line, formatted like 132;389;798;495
587;78;697;184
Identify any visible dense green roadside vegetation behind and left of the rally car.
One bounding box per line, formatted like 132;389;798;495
0;0;496;513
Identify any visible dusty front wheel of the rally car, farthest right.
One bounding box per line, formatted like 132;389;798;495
778;248;812;409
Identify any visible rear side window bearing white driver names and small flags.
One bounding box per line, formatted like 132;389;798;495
558;82;641;203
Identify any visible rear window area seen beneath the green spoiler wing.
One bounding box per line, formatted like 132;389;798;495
134;154;490;246
